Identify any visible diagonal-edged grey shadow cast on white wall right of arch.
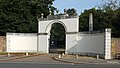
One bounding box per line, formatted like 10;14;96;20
67;34;104;56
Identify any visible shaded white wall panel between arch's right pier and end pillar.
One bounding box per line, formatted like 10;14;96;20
78;33;104;54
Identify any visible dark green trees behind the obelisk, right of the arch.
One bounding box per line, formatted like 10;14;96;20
79;1;120;37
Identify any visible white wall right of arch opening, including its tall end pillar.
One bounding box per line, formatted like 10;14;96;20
66;28;112;59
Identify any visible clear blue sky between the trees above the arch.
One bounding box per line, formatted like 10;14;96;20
53;0;102;14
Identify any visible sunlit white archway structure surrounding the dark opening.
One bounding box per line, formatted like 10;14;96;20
38;17;79;54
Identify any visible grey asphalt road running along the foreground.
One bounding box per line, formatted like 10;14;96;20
0;62;120;68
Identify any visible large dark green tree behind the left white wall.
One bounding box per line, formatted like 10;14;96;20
0;0;55;35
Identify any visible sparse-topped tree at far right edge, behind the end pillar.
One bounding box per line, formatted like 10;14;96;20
101;0;120;37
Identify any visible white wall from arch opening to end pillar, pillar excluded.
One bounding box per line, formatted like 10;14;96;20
67;33;104;55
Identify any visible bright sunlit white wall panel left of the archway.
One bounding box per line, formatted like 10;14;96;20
7;33;37;52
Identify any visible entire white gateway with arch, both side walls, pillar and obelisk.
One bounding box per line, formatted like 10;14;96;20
7;13;111;59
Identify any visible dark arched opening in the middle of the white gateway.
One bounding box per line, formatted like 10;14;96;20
49;23;66;53
